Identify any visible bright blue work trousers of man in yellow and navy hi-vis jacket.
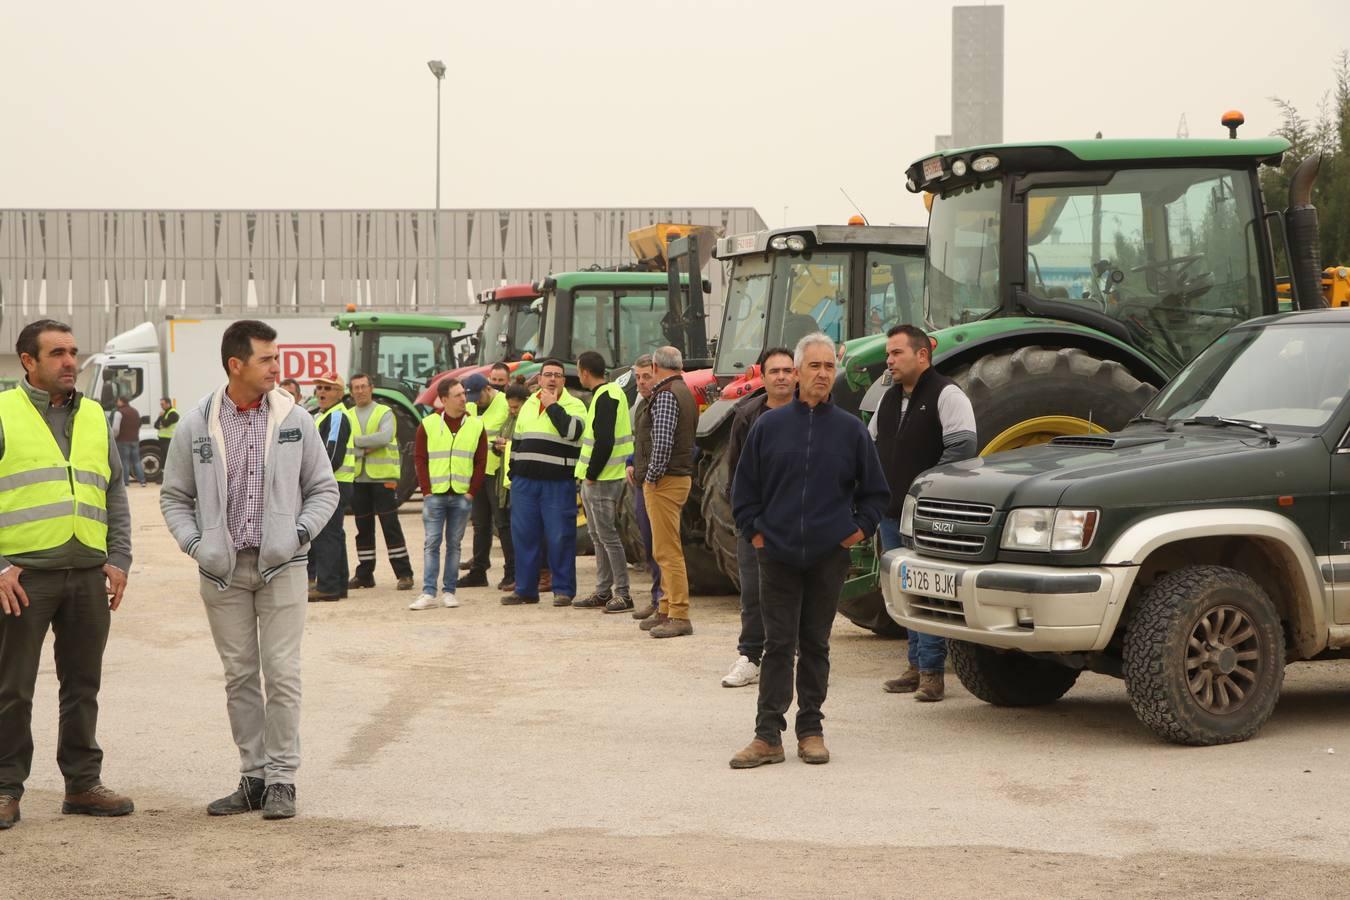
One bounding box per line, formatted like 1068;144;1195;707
510;476;576;596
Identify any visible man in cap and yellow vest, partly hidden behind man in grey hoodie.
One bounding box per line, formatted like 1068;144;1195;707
309;372;356;603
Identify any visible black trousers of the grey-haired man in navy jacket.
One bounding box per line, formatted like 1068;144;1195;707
755;546;849;745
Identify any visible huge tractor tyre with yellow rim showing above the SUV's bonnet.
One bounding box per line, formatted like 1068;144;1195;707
952;347;1157;456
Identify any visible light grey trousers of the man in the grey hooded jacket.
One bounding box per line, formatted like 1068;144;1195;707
201;551;308;784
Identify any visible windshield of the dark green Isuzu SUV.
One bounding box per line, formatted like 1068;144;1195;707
1143;324;1350;432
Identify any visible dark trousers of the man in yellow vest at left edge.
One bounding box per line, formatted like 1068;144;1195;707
0;567;111;797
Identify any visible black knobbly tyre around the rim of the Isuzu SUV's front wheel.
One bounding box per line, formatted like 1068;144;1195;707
1125;565;1284;746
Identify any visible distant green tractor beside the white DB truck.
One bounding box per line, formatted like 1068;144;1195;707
332;313;471;503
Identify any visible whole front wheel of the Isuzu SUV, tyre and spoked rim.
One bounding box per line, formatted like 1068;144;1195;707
1125;565;1284;746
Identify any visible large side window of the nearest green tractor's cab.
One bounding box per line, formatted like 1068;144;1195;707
1026;169;1262;368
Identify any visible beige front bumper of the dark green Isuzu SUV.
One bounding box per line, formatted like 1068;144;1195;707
882;549;1138;653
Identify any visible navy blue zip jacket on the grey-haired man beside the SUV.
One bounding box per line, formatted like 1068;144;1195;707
732;399;891;567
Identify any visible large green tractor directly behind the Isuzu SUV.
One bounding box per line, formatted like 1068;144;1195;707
834;130;1324;631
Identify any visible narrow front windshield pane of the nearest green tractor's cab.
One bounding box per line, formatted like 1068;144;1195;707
923;181;1003;328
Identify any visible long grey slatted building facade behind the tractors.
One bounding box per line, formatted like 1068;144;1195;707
0;206;764;349
